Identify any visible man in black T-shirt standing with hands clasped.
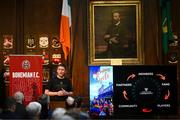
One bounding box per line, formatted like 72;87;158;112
45;64;73;109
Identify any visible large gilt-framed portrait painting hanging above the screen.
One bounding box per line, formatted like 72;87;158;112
88;1;143;65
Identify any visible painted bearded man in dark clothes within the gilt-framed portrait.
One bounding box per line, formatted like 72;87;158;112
104;11;129;58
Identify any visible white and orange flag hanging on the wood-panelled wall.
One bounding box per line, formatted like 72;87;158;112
60;0;71;60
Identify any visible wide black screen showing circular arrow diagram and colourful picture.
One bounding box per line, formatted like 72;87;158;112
89;65;177;118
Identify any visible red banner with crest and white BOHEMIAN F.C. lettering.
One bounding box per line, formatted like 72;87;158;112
9;55;42;104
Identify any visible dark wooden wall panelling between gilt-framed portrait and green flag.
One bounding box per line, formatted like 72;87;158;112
142;0;162;64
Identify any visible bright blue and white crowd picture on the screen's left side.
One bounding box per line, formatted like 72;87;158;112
89;66;113;117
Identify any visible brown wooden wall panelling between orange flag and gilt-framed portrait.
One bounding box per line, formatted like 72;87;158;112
70;0;89;104
